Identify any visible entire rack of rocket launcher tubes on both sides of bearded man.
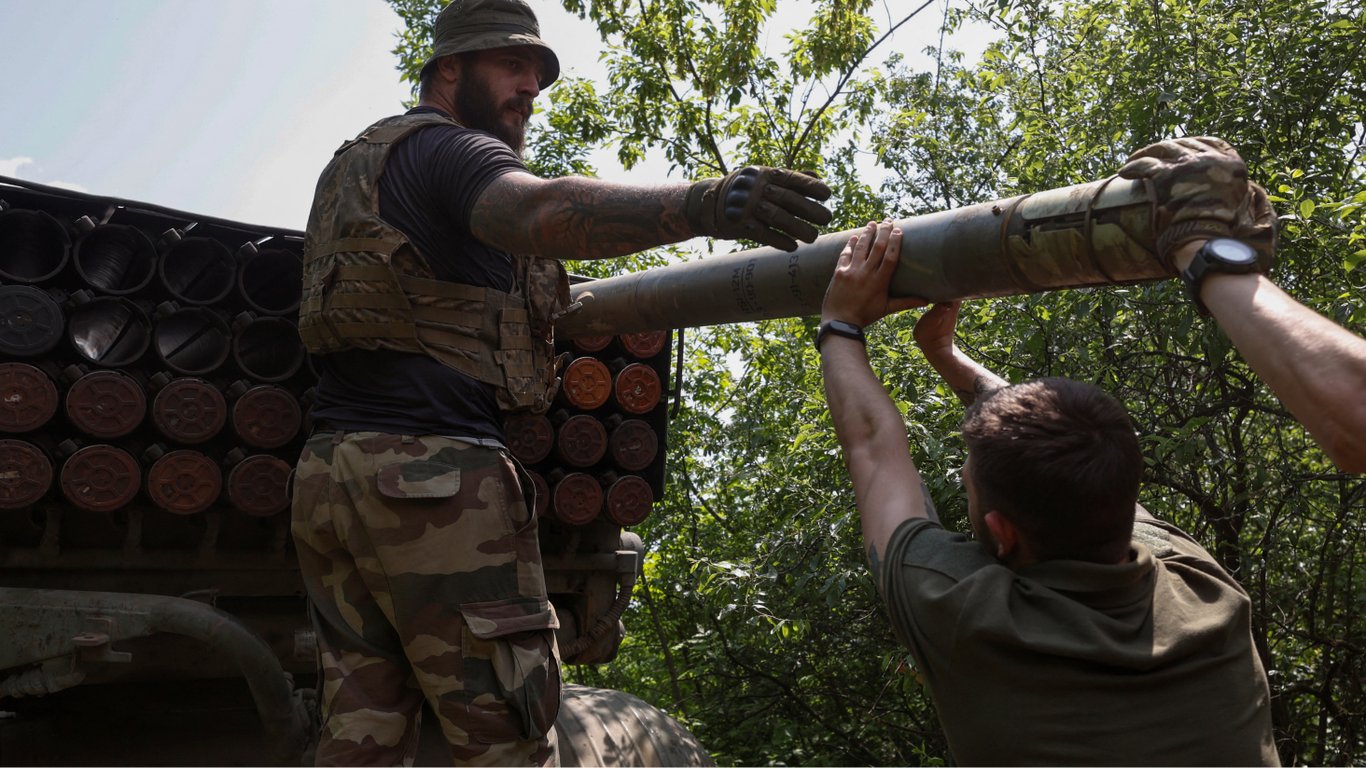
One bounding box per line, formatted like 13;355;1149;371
0;178;669;680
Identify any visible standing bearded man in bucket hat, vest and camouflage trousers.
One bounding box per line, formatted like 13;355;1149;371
292;0;831;765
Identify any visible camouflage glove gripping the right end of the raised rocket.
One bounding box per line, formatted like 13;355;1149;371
1119;137;1276;268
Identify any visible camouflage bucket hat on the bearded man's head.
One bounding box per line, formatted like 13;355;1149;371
422;0;560;89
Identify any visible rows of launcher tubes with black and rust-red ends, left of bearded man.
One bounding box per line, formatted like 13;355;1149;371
0;190;311;524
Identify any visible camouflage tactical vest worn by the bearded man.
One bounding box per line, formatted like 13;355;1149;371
299;113;570;413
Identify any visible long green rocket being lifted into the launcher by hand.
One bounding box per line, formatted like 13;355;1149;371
556;178;1175;336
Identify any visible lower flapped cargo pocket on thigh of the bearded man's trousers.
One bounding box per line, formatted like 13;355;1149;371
460;597;560;743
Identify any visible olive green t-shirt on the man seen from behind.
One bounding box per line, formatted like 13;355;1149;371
882;511;1279;765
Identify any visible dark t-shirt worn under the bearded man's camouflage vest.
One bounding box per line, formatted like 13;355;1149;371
313;107;526;443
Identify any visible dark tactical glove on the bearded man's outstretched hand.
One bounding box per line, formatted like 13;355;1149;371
684;165;831;250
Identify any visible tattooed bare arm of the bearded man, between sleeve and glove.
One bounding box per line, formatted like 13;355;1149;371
470;174;693;260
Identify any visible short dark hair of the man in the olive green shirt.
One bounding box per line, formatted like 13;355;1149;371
963;379;1143;563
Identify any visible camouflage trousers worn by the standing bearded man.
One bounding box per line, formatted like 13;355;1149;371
292;432;560;765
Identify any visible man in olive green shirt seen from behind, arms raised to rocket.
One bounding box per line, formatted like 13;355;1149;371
817;223;1277;765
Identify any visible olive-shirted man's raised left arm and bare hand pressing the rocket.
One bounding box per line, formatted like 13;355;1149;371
820;223;937;573
